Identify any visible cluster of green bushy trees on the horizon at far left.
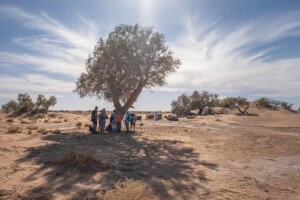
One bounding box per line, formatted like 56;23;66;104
1;93;57;114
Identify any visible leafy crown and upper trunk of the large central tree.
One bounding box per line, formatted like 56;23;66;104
75;25;180;113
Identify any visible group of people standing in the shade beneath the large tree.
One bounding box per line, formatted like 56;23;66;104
91;106;136;134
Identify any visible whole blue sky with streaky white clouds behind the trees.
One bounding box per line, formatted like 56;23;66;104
0;0;300;111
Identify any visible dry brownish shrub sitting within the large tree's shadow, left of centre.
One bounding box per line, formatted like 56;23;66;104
57;149;99;168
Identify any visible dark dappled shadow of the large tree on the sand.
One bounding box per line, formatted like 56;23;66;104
18;133;218;199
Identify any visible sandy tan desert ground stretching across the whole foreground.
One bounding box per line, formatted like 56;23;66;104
0;108;300;200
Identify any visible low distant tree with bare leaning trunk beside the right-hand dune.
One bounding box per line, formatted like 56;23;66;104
222;97;249;114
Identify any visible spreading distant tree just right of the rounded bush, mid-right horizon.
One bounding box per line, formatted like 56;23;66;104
191;90;219;115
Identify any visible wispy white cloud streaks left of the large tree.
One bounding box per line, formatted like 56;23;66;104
0;6;99;78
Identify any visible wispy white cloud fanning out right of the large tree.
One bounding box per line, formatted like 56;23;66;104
163;12;300;97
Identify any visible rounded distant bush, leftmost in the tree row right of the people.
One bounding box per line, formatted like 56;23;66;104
171;94;191;117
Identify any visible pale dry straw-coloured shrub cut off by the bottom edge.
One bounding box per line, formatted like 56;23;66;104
97;179;153;200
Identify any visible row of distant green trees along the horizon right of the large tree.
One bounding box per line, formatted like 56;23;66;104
171;90;293;117
